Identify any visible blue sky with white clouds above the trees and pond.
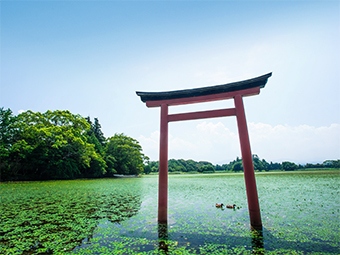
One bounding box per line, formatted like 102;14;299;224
0;0;340;164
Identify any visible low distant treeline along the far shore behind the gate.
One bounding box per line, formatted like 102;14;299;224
144;154;340;174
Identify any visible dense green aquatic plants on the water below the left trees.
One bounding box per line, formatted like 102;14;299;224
0;180;141;254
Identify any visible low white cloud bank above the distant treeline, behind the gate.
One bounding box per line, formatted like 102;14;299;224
139;121;340;163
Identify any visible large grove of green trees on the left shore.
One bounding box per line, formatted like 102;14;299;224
0;108;148;181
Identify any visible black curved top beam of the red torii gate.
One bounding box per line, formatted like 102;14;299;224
136;73;272;102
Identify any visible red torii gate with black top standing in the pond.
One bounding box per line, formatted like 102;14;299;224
136;73;272;229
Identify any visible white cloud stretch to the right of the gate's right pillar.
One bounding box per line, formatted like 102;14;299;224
249;123;340;163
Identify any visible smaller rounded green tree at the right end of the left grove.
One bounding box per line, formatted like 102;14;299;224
105;134;146;175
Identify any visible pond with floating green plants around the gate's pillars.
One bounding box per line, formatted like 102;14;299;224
0;171;340;254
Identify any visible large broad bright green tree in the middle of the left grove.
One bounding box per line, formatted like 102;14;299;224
3;111;106;179
